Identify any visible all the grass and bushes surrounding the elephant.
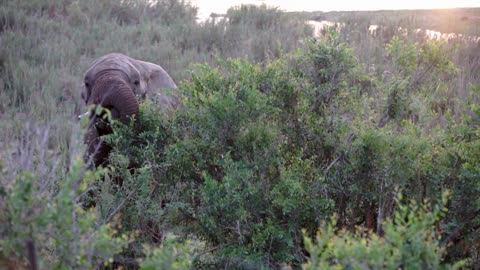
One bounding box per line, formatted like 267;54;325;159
0;0;480;269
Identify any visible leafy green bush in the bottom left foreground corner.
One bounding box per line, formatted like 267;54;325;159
0;128;133;269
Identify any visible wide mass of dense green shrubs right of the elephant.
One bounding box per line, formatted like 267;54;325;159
100;31;471;268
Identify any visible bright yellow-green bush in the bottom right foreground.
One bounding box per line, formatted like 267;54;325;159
303;193;464;269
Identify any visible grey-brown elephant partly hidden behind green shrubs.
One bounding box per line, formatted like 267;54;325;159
81;53;180;167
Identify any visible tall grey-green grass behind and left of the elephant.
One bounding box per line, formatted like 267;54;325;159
0;0;309;165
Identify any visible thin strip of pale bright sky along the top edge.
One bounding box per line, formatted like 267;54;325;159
190;0;480;19
